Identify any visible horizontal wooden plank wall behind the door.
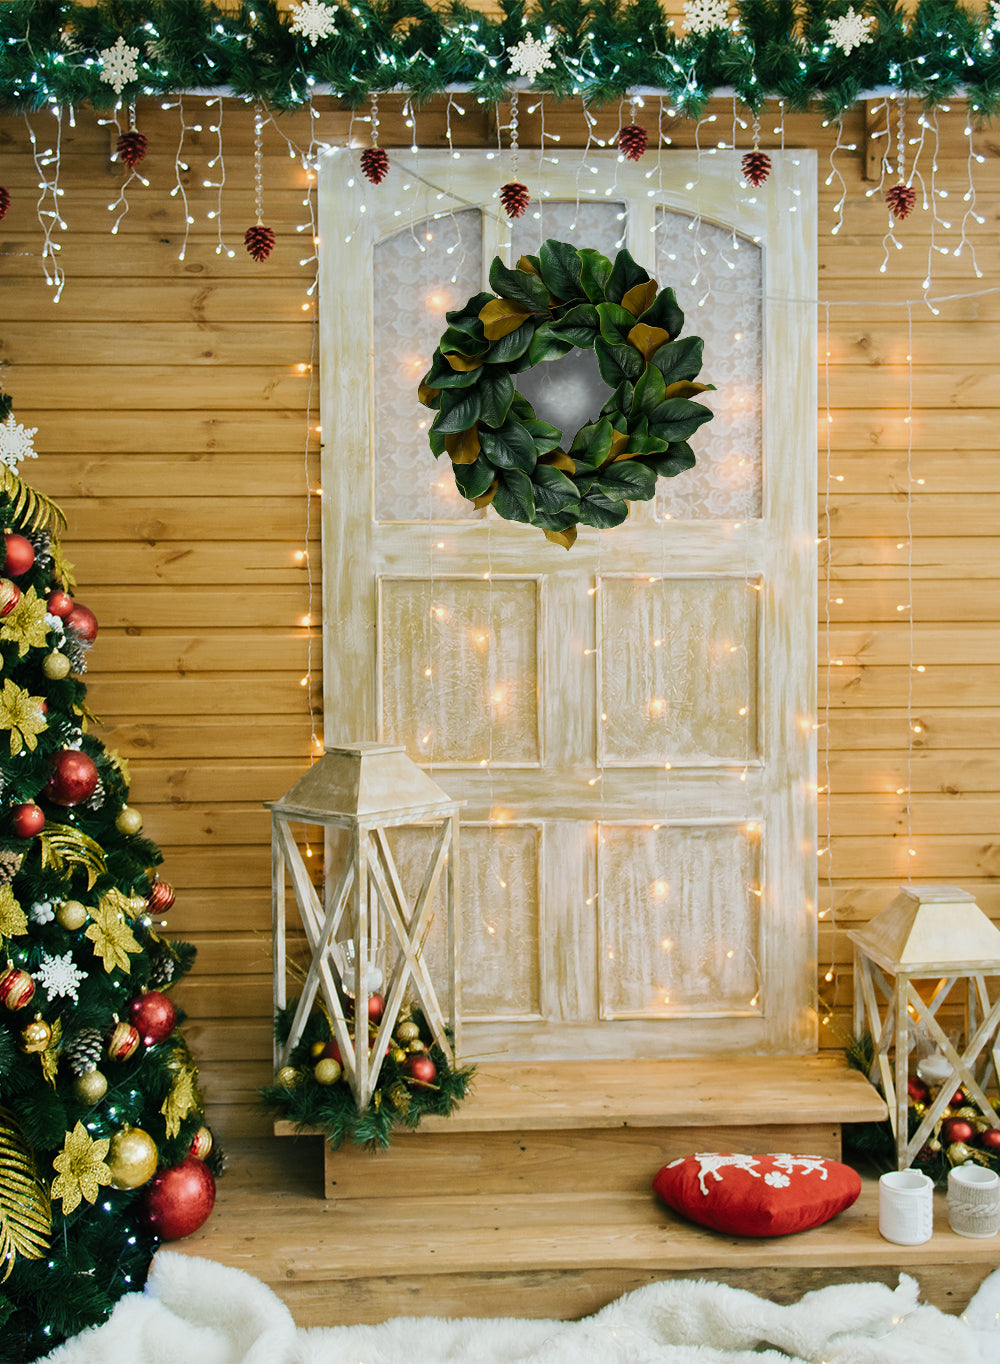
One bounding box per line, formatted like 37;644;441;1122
0;97;1000;1138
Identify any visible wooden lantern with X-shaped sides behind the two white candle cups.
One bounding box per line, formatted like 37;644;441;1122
847;885;1000;1170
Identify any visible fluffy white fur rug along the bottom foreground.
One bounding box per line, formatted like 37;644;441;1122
40;1251;1000;1364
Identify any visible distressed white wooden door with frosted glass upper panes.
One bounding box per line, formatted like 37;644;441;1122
321;150;816;1058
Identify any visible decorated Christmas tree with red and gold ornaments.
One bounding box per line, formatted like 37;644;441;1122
0;391;218;1361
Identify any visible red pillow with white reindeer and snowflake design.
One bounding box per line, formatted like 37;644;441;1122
652;1153;861;1236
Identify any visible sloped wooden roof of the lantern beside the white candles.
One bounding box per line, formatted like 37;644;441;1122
847;885;1000;975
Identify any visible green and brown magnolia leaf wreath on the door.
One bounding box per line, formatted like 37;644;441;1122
419;240;714;550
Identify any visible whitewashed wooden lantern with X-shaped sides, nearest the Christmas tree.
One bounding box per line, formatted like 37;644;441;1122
270;743;460;1109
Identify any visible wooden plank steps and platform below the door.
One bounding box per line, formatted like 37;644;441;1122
169;1057;1000;1326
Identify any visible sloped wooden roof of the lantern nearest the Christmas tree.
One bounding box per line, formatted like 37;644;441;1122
269;743;461;824
